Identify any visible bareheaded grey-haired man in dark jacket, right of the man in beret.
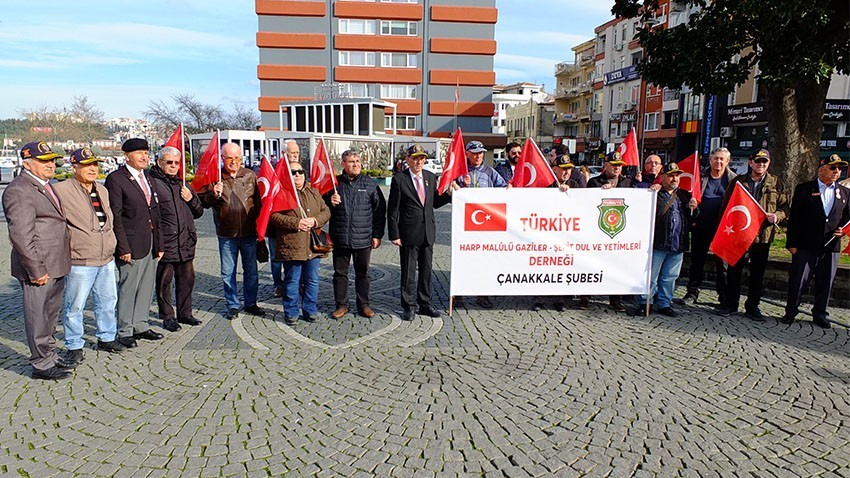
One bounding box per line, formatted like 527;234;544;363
150;146;204;332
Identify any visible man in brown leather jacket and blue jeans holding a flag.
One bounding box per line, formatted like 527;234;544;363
198;143;266;320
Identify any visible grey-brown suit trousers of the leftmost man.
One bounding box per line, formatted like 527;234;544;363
20;277;65;370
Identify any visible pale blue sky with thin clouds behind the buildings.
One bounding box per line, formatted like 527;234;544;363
0;0;613;118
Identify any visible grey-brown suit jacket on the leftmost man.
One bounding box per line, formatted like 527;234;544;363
3;171;71;281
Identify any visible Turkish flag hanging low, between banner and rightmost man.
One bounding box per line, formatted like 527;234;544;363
709;182;766;266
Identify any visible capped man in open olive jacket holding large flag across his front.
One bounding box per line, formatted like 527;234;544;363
719;149;788;322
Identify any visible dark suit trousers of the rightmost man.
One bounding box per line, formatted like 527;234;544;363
785;249;839;320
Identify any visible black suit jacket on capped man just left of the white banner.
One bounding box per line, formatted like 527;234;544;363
387;169;452;246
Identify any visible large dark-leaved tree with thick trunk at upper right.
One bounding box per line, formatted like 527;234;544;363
611;0;850;187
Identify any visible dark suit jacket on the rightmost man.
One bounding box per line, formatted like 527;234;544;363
785;180;850;252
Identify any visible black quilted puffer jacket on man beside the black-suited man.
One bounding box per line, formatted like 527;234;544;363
324;174;387;249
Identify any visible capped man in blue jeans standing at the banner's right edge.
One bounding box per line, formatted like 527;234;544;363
634;163;699;317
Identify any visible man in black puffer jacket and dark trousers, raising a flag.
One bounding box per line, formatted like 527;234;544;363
325;149;387;319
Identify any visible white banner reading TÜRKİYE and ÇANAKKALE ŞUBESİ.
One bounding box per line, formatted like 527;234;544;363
451;188;656;296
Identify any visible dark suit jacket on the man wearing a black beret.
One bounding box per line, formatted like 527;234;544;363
106;165;162;259
